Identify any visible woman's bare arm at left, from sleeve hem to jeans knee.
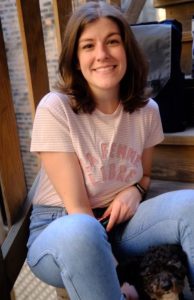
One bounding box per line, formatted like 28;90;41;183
40;152;93;215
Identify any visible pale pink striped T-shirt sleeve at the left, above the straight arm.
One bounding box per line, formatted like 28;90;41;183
30;93;74;152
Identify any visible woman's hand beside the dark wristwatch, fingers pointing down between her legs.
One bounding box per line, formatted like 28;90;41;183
103;186;141;231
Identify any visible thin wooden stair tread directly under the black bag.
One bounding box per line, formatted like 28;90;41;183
161;127;194;146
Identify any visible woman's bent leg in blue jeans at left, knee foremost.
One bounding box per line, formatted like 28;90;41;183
28;210;122;300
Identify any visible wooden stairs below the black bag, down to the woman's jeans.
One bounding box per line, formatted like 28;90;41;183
148;127;194;197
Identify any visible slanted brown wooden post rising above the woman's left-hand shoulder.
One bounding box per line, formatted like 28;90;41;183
16;0;49;114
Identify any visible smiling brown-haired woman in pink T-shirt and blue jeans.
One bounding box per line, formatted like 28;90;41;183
28;2;194;300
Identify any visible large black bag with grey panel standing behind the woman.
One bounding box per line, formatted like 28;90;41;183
131;20;185;132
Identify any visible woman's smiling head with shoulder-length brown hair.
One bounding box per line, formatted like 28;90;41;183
58;1;148;113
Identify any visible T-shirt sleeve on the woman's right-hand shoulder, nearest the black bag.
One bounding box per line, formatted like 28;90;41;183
144;99;164;148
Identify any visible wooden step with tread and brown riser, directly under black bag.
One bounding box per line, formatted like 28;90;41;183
153;128;194;183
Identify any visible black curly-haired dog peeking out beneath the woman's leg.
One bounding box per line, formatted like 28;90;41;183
117;245;187;300
